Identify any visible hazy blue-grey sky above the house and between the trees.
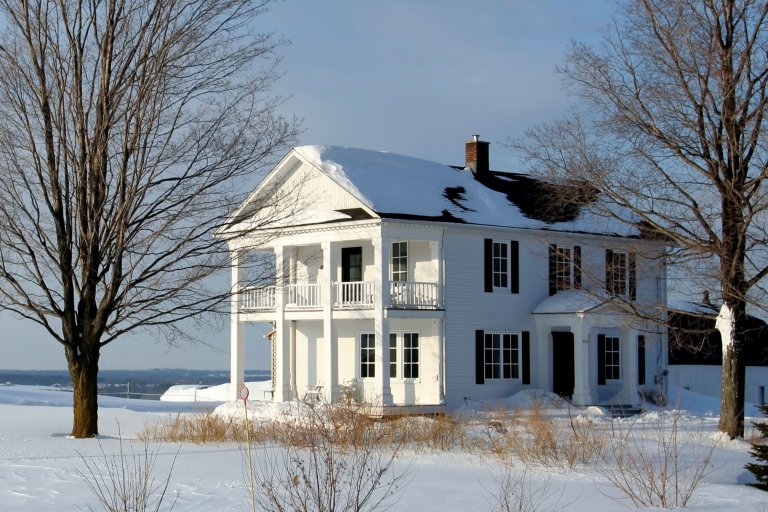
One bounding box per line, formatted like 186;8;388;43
0;0;610;370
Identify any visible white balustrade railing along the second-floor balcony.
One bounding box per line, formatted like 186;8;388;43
240;281;440;311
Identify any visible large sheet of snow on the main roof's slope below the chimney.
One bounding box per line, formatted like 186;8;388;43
295;146;639;236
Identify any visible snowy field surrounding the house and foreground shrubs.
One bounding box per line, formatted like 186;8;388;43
0;386;768;512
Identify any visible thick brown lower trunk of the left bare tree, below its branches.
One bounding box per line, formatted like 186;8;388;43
66;344;99;438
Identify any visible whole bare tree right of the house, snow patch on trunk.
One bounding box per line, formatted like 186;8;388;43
508;0;768;437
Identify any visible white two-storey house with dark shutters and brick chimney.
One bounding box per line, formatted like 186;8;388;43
217;136;667;411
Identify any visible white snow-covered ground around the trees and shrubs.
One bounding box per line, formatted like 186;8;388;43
0;384;768;512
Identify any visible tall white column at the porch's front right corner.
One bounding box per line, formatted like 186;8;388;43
373;237;392;405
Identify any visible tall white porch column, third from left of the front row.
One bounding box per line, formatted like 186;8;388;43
319;242;339;402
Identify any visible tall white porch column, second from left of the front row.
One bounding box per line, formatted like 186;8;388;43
275;247;291;402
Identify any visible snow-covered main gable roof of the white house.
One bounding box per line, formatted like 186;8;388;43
218;146;640;237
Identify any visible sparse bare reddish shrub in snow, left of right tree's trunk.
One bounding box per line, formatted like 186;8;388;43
598;409;718;508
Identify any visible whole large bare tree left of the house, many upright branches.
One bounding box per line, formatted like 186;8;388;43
0;0;297;437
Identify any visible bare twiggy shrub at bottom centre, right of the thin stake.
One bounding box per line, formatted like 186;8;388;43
243;405;410;512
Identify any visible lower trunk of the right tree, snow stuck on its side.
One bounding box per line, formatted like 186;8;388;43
717;304;746;439
